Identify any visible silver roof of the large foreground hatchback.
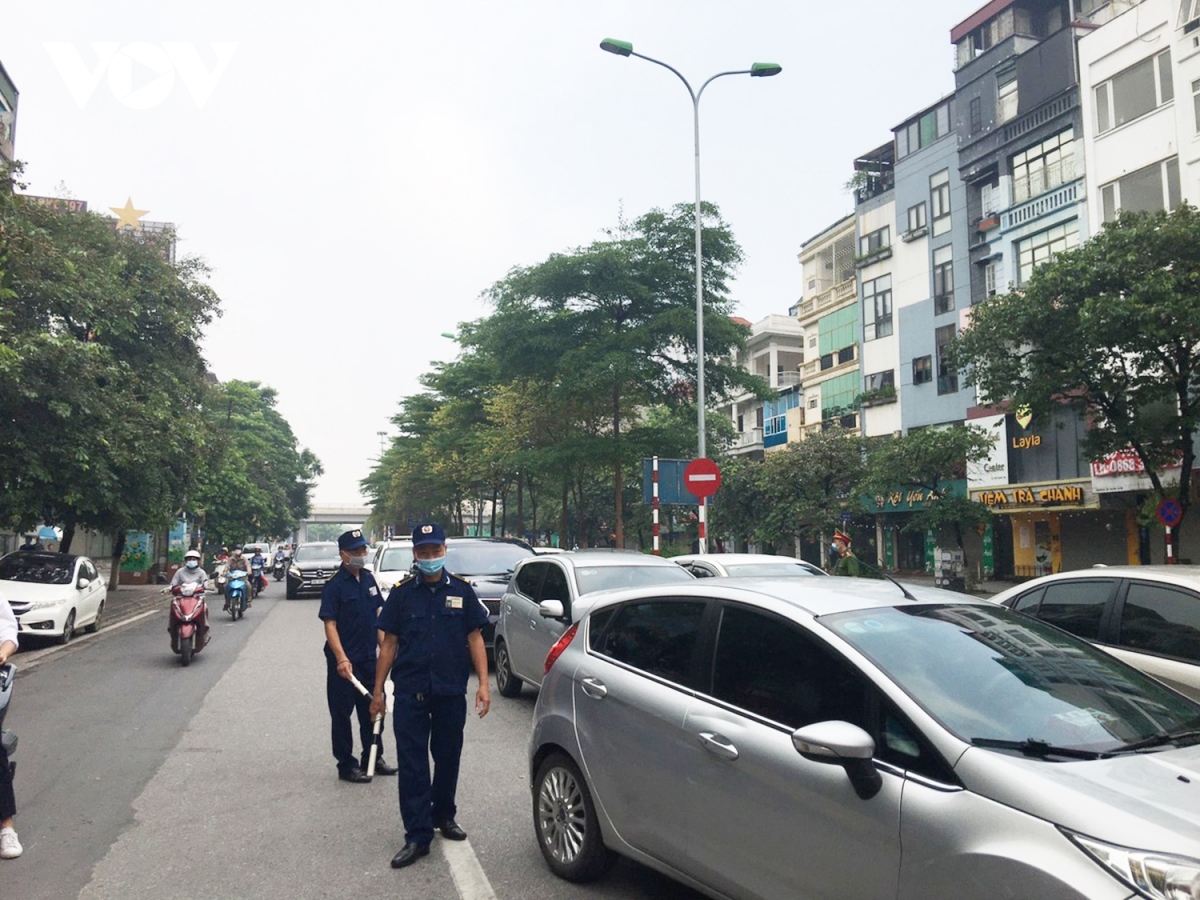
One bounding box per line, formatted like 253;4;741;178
578;577;974;617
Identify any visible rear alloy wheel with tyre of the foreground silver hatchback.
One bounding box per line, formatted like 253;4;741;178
533;754;617;882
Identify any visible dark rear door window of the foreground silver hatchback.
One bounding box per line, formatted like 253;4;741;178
595;602;704;684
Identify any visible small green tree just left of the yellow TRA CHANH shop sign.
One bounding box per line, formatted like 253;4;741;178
859;426;994;571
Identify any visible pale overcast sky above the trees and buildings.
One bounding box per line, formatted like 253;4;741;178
0;0;984;505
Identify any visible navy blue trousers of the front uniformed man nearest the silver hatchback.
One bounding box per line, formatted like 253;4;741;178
391;691;467;844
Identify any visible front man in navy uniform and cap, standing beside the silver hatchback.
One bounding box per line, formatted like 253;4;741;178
371;524;491;869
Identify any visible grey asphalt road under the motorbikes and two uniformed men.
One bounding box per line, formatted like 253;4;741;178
0;582;700;900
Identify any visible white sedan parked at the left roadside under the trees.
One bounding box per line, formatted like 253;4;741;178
0;551;106;643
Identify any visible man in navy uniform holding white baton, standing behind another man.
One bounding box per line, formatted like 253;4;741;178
318;528;396;784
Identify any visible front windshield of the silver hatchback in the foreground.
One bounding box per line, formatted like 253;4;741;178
818;605;1200;752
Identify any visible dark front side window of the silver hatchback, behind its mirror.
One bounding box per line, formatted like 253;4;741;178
713;606;870;728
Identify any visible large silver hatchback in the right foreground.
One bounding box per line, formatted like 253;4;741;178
529;578;1200;900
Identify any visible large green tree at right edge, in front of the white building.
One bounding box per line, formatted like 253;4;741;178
954;204;1200;540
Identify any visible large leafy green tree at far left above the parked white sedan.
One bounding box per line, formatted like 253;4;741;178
0;164;218;566
